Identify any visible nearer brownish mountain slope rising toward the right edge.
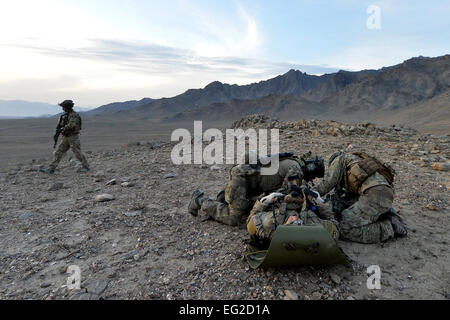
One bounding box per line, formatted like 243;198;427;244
168;55;450;127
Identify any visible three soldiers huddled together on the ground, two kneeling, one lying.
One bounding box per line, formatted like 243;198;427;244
188;152;408;244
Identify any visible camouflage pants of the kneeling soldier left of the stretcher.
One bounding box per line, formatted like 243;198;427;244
200;171;256;226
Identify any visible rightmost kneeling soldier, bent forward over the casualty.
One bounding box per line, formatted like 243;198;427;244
317;152;407;243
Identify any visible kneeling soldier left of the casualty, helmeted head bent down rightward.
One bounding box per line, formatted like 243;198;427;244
188;154;325;226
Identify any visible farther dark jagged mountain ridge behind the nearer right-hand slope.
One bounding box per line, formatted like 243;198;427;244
86;65;379;120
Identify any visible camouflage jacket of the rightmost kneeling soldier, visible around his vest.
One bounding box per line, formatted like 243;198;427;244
316;153;390;195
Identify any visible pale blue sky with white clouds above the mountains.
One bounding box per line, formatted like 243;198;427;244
0;0;450;107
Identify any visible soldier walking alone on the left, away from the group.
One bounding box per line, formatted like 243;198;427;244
41;100;89;174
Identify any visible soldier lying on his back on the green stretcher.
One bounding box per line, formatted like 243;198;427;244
247;192;339;249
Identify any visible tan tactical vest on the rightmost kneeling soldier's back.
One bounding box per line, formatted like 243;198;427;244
346;152;395;194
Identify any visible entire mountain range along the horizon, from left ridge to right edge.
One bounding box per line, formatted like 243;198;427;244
88;55;450;131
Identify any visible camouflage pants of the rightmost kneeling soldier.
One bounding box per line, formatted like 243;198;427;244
339;186;394;243
